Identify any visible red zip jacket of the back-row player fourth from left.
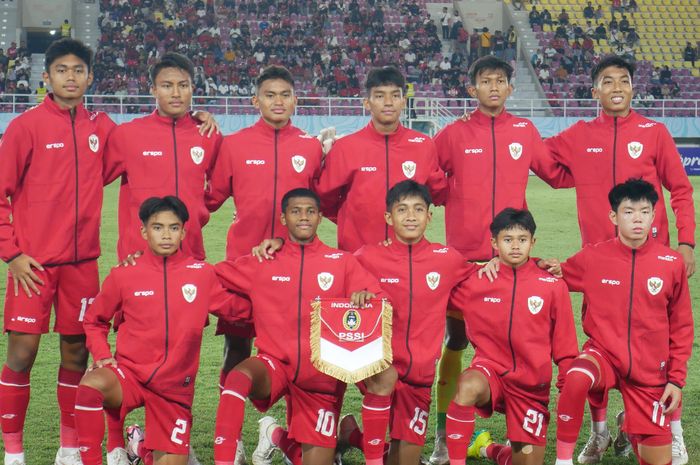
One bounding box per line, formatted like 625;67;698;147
316;121;447;252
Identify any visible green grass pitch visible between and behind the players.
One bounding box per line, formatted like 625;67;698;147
0;178;700;465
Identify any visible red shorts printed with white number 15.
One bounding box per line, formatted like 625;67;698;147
389;380;431;446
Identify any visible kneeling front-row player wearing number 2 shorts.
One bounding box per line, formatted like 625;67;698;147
75;196;234;465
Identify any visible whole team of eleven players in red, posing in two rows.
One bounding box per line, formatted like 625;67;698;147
0;40;695;465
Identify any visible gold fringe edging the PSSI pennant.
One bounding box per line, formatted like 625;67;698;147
310;299;394;383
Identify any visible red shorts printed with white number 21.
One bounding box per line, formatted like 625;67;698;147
468;361;549;446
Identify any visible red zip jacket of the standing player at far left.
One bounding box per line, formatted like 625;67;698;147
0;94;114;266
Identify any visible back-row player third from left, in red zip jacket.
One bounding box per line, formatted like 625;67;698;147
202;66;323;424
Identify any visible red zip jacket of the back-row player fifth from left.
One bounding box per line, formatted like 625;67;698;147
435;110;573;261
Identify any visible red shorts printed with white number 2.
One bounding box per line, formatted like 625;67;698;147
107;367;192;455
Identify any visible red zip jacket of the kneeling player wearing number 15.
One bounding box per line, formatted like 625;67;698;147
355;239;478;387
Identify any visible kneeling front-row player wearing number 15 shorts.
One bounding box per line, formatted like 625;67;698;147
340;180;477;465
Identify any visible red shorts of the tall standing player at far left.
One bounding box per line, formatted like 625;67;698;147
5;260;100;336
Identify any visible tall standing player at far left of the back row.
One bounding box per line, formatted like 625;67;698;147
0;39;114;465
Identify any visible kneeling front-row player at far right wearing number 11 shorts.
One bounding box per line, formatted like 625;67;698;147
557;179;693;465
